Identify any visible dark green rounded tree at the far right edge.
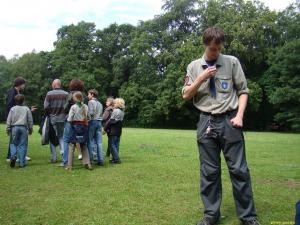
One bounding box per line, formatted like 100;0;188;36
263;39;300;130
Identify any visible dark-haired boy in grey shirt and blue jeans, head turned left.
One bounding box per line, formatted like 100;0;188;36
88;89;103;166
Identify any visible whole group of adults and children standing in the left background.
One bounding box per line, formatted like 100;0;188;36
7;77;125;170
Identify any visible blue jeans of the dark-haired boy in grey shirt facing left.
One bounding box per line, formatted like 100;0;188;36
88;120;103;162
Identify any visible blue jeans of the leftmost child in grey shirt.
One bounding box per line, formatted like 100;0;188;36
10;126;28;167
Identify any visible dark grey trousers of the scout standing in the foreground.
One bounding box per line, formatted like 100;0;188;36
197;112;257;220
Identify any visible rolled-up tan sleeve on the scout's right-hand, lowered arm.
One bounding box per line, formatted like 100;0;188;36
232;58;249;96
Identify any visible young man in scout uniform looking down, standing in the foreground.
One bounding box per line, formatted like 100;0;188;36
182;27;259;225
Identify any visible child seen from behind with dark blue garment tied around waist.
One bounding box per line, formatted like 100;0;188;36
66;91;93;170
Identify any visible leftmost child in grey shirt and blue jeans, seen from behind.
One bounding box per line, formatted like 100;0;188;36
6;94;33;168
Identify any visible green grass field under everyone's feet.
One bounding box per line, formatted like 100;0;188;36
0;125;300;225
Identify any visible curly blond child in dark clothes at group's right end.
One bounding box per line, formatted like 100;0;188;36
105;98;125;164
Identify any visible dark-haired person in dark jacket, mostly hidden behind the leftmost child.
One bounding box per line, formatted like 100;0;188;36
5;77;36;162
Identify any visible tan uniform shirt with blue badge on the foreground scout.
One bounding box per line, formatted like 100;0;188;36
182;54;249;114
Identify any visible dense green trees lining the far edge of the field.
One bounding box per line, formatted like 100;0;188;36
0;0;300;130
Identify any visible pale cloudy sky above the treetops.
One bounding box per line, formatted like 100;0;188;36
0;0;296;58
